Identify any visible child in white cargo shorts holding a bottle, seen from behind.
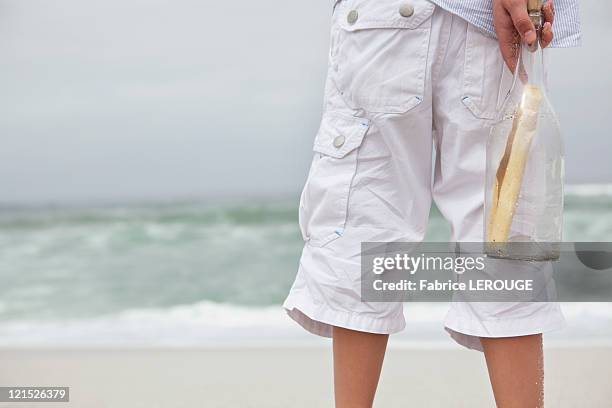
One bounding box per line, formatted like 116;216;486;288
284;0;580;408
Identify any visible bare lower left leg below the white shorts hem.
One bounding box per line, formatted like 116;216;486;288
333;327;389;408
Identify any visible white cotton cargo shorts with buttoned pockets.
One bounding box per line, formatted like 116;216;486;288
284;0;564;349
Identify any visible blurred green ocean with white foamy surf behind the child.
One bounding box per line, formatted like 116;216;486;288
0;186;612;347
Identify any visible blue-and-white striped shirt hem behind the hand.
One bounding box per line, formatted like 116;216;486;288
431;0;581;48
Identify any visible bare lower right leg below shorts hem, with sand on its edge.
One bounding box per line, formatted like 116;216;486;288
480;334;544;408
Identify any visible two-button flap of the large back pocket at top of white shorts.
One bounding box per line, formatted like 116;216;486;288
338;0;435;31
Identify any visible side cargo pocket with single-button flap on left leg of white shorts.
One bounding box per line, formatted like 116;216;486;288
299;113;370;246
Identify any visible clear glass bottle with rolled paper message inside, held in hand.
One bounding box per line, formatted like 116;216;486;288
484;0;564;261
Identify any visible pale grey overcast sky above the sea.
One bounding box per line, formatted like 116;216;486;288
0;0;612;203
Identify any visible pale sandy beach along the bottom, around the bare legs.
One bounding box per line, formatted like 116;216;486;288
0;347;612;408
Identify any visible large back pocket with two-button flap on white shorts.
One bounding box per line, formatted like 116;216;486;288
330;0;435;113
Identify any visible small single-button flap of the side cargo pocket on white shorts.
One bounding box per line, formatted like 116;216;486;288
313;113;370;159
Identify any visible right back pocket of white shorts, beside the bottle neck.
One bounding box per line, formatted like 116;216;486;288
461;24;504;119
